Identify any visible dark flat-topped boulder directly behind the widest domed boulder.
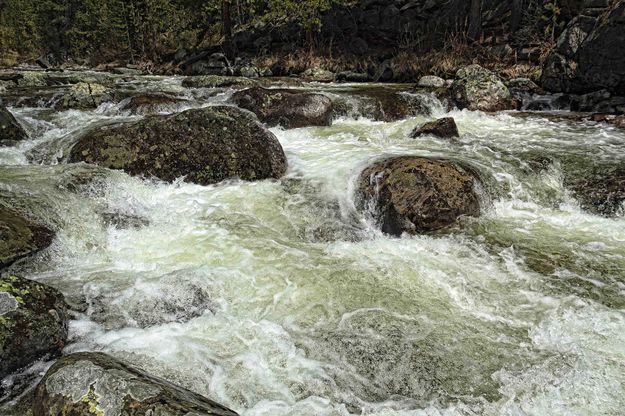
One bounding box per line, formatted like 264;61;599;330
232;87;332;128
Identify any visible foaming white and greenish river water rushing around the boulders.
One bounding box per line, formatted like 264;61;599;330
0;78;625;416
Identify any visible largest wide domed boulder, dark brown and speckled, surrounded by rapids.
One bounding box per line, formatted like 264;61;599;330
69;106;287;185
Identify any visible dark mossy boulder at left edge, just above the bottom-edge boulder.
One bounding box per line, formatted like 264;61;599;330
0;276;67;379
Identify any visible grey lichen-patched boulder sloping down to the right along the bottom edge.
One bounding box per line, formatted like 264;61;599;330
26;352;237;416
